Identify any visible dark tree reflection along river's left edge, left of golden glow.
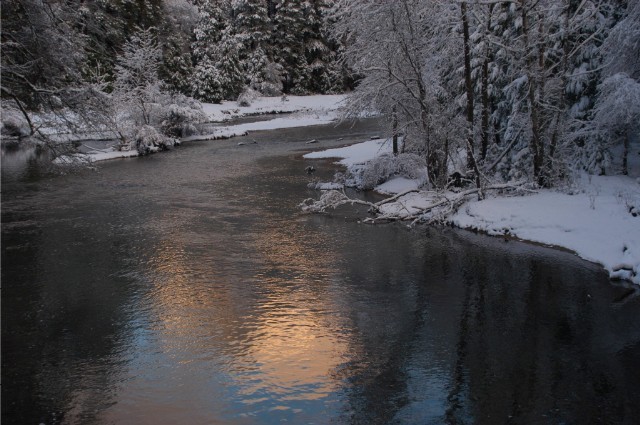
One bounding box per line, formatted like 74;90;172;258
2;197;151;423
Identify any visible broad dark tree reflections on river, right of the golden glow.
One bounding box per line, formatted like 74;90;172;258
336;229;640;423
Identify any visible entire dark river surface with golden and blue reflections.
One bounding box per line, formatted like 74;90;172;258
2;122;640;424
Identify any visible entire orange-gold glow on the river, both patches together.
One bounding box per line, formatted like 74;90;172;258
99;217;356;422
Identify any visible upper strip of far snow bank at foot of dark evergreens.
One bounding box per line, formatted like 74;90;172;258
202;94;346;122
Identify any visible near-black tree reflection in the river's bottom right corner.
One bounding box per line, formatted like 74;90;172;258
447;237;638;423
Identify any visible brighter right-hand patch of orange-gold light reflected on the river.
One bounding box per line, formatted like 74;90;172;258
234;222;348;403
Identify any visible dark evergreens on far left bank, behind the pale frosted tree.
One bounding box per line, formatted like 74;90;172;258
2;0;349;105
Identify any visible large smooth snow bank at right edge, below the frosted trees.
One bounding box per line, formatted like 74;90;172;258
451;176;640;284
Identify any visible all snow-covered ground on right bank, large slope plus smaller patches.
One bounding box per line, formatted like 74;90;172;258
304;140;640;284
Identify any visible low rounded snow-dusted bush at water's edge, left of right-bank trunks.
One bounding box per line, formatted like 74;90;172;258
346;153;427;190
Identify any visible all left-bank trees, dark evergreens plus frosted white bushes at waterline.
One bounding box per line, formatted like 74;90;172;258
1;0;351;152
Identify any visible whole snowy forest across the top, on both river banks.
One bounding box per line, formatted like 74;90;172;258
2;0;640;188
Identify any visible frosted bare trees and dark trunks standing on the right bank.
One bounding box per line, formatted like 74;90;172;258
334;0;640;187
